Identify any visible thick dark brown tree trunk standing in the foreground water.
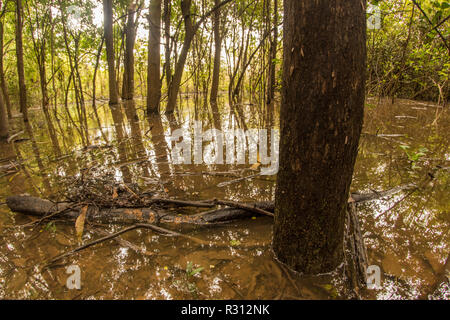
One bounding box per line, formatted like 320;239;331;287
273;0;366;274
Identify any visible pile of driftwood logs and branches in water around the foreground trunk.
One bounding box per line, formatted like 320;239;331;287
2;184;417;296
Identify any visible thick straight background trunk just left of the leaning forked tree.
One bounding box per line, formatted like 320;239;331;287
147;0;162;114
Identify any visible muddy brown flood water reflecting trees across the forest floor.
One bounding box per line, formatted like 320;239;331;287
0;99;450;299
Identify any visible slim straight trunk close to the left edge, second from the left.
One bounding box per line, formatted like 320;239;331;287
16;0;28;122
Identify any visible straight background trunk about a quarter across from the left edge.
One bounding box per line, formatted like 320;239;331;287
103;0;119;106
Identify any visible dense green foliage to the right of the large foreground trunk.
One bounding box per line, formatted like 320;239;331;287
367;0;450;102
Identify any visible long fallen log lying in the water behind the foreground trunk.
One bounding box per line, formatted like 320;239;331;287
6;184;416;224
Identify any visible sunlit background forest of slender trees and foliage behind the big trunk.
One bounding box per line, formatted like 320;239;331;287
0;0;442;140
